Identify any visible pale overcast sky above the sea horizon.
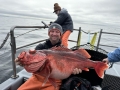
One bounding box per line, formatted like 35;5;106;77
0;0;120;28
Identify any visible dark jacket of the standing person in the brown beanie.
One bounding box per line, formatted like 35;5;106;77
54;8;73;33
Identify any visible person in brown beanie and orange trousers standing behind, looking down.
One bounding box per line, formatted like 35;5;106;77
53;3;73;47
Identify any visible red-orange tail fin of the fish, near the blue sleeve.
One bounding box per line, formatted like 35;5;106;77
94;62;109;78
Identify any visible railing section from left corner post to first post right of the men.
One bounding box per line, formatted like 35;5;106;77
10;25;81;78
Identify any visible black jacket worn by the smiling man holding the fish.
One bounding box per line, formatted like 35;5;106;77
35;39;61;50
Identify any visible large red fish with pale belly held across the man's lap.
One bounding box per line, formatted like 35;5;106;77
18;47;108;87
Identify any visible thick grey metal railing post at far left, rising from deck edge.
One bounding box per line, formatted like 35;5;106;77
10;27;18;79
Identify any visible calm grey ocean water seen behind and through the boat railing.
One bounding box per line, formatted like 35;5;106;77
0;15;120;83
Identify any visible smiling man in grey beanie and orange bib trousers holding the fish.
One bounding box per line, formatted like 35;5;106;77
15;23;81;90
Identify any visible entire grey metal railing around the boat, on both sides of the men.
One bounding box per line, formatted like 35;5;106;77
10;25;120;78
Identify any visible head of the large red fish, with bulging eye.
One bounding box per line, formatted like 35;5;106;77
18;49;46;72
